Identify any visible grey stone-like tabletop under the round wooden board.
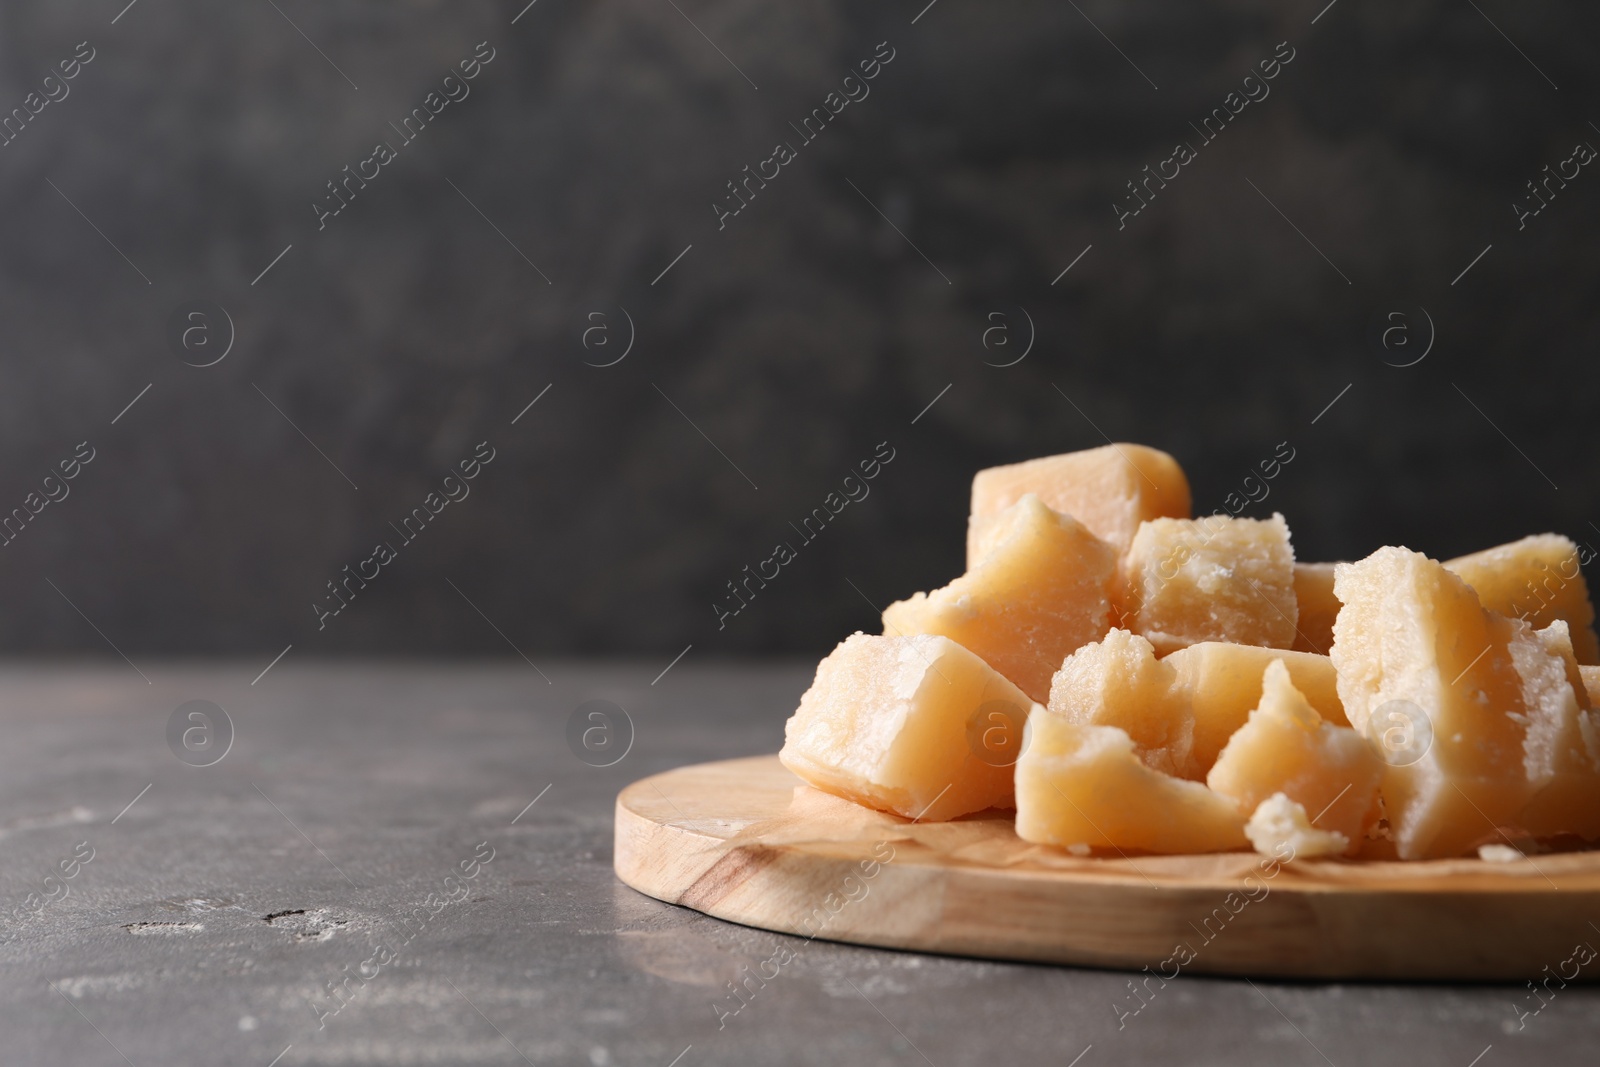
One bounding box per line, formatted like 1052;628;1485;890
0;657;1600;1067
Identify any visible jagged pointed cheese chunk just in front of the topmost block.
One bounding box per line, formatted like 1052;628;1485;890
883;493;1117;701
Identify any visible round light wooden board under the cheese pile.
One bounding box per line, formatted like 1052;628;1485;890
616;757;1600;981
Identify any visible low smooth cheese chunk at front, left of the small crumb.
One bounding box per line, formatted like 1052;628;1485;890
1016;709;1246;853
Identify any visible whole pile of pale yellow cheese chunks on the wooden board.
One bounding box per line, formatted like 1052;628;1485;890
800;445;1600;859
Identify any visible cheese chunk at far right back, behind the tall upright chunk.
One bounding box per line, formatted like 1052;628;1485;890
1445;534;1600;664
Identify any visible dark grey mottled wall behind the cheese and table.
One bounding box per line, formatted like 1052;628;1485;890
0;0;1600;659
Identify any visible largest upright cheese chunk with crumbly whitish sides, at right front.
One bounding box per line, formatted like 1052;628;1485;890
1330;547;1576;859
